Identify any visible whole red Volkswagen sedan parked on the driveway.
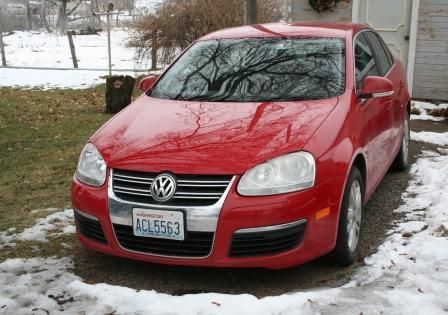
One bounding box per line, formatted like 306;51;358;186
72;23;410;269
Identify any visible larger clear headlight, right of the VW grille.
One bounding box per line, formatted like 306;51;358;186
238;152;316;196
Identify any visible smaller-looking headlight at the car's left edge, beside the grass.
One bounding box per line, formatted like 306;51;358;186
76;143;106;186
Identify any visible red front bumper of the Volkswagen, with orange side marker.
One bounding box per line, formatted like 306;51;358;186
72;177;344;269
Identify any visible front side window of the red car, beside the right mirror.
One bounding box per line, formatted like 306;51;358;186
355;34;379;90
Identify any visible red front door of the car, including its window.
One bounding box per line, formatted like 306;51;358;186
354;32;393;194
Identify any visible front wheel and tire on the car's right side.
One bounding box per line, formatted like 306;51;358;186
333;166;364;266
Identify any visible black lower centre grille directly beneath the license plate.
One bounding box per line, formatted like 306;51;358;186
114;224;214;257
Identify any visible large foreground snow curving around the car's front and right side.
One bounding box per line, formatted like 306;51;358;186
0;149;448;315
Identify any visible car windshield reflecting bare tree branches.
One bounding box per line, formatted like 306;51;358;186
151;37;345;102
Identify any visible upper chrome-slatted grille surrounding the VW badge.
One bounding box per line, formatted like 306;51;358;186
112;170;232;206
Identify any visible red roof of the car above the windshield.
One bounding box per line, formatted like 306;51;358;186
200;22;369;40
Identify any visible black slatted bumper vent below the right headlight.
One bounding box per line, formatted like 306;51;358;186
229;223;306;257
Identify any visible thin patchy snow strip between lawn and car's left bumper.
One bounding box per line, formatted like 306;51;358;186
0;208;75;250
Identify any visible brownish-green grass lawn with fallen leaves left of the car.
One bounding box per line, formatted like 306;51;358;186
0;87;111;231
